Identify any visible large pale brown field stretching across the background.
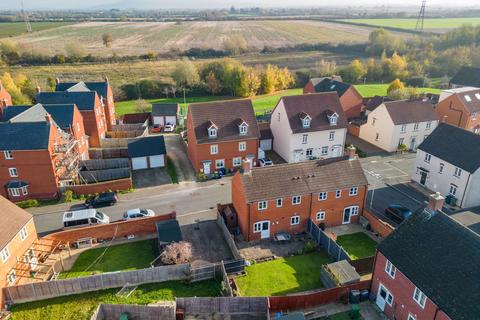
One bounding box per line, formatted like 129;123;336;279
6;20;372;55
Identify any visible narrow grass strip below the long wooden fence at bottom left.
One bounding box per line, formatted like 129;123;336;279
10;280;220;320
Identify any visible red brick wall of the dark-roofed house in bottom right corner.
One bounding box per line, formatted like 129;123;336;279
371;251;449;320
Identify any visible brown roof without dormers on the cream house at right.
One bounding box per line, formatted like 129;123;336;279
384;100;438;125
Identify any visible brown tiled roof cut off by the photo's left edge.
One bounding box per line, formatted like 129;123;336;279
0;196;32;249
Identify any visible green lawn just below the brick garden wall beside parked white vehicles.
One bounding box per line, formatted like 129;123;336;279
59;239;157;279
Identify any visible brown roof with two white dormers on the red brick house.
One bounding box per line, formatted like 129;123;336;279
189;100;260;143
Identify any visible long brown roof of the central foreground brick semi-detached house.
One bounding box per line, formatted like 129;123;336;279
241;157;368;203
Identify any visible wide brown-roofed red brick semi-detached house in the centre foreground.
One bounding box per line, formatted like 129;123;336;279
232;157;367;241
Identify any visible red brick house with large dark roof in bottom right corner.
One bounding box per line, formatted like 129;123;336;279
371;199;480;320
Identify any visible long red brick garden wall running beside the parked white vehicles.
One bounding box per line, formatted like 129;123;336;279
42;212;177;243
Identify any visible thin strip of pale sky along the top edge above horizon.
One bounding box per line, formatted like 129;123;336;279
0;0;480;10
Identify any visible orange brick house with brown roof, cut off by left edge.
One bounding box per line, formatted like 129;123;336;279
0;196;38;309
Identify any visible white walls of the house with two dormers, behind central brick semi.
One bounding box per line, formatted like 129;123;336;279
270;101;347;163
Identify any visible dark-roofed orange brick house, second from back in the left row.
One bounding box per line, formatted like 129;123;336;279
36;89;107;148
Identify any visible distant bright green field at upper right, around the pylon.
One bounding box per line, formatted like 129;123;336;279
339;17;480;30
